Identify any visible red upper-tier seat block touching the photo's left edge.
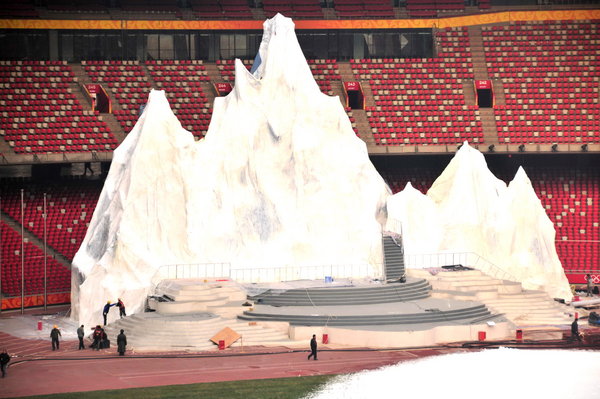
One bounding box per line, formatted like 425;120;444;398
0;61;117;154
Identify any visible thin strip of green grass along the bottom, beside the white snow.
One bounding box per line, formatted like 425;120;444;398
19;375;334;399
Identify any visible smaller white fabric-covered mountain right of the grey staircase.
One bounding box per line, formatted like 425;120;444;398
386;142;571;299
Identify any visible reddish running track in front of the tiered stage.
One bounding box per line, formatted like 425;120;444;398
0;333;460;397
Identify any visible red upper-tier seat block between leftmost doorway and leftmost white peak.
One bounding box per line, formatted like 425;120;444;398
81;61;150;133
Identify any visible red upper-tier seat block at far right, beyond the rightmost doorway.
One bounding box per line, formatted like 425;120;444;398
482;21;600;144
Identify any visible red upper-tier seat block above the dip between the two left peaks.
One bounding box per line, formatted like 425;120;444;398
146;60;212;137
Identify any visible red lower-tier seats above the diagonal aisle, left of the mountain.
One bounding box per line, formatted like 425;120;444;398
2;180;102;259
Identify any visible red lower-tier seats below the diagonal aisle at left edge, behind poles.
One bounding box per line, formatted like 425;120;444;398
0;221;71;297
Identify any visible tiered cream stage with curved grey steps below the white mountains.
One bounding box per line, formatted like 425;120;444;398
102;278;513;351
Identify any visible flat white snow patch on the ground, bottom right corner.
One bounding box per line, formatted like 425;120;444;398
306;348;600;399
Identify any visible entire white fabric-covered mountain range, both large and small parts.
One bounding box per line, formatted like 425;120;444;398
71;15;570;326
